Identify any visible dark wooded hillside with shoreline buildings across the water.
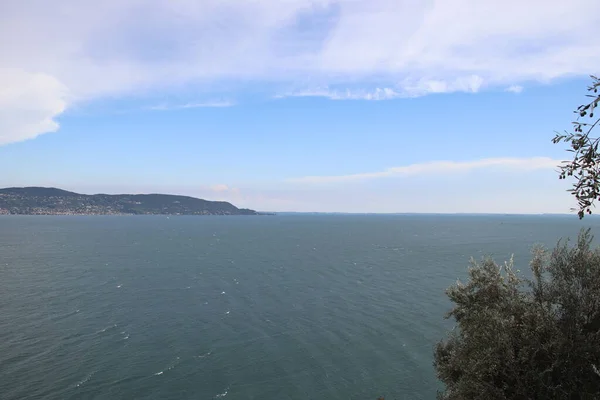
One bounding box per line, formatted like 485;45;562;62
0;187;258;215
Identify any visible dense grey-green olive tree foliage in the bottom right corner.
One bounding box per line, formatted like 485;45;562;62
434;230;600;400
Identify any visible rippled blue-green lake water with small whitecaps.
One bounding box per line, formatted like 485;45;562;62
0;215;600;400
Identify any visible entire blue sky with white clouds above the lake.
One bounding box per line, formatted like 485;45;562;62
0;0;600;213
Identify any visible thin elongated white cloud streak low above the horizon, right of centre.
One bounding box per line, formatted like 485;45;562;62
289;157;560;184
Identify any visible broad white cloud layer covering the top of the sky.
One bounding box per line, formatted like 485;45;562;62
0;0;600;143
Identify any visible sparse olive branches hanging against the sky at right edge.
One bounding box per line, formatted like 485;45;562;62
552;76;600;218
